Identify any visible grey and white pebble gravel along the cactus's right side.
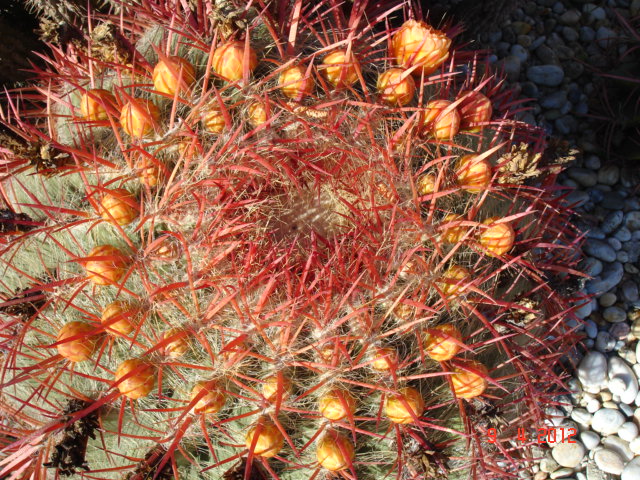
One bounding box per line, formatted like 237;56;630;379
444;0;640;480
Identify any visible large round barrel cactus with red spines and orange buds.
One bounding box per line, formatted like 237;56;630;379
0;0;579;480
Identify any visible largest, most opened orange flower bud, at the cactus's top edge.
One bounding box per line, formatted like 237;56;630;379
391;20;451;75
